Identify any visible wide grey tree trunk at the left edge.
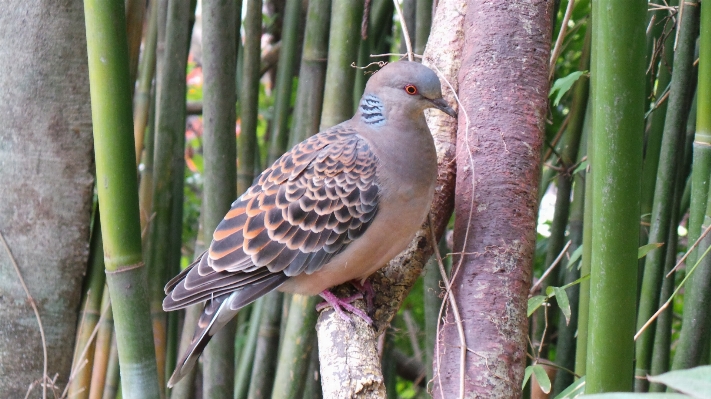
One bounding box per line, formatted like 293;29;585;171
0;0;93;398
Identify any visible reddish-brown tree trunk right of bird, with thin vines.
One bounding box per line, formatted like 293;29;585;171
433;0;553;398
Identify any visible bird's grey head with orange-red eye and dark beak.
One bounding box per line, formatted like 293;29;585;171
361;61;457;118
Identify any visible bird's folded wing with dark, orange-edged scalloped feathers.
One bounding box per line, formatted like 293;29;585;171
163;126;380;310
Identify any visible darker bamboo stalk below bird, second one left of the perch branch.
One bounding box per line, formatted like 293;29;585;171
247;291;284;399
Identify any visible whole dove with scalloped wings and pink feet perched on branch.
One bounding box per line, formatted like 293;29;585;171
163;61;456;387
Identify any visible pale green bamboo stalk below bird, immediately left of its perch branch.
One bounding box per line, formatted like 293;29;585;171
271;295;318;399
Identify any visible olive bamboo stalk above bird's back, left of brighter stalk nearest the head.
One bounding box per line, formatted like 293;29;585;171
289;0;331;147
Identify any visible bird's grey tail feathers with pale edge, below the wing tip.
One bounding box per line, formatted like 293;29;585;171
168;273;289;388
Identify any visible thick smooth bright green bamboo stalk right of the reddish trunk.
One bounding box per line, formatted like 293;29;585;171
586;0;647;393
